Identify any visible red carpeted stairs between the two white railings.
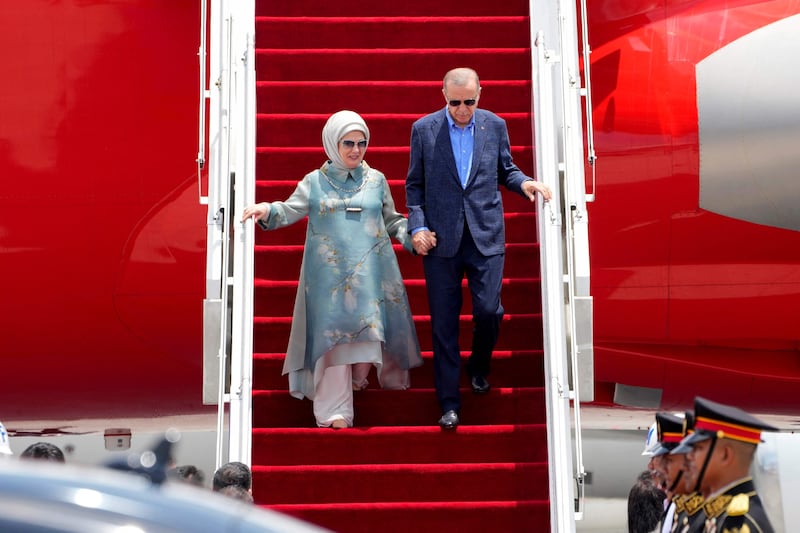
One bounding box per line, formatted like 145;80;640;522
253;0;549;533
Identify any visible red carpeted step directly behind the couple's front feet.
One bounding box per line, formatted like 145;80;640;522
253;387;545;427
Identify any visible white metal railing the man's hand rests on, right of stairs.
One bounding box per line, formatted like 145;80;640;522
530;0;594;532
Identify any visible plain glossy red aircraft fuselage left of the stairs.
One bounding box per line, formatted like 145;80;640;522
0;0;205;420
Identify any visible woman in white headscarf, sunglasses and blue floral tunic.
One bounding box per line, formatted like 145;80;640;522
243;111;422;428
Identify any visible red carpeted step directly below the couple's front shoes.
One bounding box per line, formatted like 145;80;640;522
253;424;547;466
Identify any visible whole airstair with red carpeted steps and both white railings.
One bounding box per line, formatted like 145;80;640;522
199;0;592;531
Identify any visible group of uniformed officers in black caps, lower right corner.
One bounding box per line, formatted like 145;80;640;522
628;397;777;533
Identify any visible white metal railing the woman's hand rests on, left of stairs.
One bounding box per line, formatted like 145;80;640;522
203;0;255;466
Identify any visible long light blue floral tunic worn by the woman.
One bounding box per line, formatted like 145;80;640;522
259;162;422;399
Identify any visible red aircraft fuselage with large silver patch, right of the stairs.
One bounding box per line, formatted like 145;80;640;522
589;1;800;411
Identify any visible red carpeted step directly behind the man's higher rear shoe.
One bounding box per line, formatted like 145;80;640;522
253;350;544;391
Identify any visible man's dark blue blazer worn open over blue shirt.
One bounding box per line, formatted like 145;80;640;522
406;109;531;257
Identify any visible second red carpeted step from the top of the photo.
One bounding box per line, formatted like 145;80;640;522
256;14;530;50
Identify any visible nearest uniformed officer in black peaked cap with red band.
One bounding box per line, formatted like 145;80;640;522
673;397;777;533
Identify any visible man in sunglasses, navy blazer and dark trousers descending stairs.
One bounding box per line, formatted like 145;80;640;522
406;68;551;429
